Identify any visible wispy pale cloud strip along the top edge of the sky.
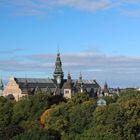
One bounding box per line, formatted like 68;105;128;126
0;0;140;16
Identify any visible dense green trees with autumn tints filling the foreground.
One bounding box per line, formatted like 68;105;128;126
0;91;140;140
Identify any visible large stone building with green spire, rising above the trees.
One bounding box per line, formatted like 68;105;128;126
3;52;100;101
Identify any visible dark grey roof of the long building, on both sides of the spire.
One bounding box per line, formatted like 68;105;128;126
14;78;100;94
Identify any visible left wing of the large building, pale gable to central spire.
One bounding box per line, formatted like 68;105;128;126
3;77;56;101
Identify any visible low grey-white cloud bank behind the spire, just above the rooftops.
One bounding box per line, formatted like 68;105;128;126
0;52;140;86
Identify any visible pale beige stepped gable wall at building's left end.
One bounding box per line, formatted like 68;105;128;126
3;78;26;101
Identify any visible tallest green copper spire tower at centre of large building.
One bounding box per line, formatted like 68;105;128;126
53;50;64;86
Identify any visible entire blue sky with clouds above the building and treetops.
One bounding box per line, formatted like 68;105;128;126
0;0;140;87
